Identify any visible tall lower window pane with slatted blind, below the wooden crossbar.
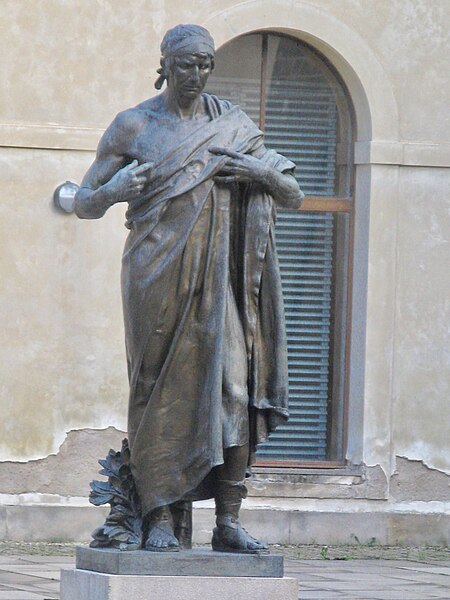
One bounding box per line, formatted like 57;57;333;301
257;211;348;461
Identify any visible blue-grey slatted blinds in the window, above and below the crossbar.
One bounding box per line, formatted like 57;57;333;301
208;44;337;461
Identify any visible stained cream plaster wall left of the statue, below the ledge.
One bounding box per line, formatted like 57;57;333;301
0;148;127;460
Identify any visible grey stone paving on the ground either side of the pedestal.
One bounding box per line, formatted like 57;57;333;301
0;555;450;600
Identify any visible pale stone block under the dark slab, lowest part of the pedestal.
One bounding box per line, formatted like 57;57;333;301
61;569;298;600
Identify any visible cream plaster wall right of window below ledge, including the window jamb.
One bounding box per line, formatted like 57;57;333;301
362;159;450;477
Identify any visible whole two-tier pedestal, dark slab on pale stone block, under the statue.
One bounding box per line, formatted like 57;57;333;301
61;548;298;600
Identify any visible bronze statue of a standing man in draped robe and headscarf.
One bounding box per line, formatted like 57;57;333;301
75;25;303;552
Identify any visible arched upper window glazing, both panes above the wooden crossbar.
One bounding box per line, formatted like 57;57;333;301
207;33;352;196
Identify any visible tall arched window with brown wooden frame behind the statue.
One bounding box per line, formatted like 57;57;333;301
208;32;353;466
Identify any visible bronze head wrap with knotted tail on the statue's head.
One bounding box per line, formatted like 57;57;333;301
155;25;215;90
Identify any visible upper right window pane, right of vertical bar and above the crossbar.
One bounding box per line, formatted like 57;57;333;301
264;36;345;196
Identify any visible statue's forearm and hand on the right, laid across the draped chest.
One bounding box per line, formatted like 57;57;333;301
209;147;305;208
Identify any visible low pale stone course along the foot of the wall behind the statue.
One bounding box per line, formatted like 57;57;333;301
0;506;450;546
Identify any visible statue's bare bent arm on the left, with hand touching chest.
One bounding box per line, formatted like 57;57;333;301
75;111;153;219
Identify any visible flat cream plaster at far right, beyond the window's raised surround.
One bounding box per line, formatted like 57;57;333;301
392;167;450;473
